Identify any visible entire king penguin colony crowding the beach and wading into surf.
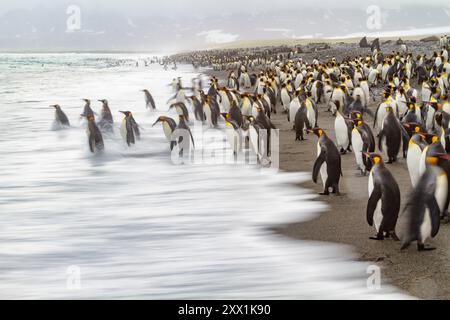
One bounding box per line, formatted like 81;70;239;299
54;38;450;251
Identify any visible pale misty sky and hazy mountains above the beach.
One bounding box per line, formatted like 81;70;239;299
0;0;450;52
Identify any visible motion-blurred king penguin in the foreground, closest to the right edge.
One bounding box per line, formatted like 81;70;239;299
400;154;450;251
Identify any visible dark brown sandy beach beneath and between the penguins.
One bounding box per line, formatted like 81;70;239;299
208;42;450;299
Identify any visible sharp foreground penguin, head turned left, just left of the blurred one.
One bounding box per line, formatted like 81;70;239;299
364;153;400;240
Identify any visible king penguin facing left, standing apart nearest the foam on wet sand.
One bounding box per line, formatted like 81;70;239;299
309;128;342;196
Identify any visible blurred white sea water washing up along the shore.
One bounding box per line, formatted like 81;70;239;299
0;54;406;299
